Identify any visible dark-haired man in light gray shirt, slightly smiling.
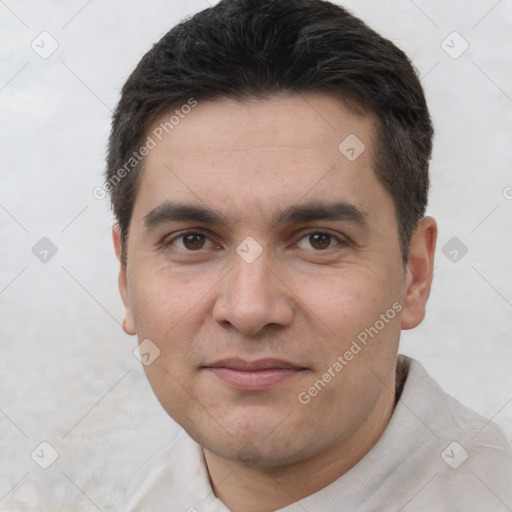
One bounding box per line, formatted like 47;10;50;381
107;0;512;512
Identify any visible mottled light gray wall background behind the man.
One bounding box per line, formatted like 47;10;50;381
0;0;512;512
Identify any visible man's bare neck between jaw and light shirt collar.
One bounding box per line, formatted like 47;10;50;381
204;374;395;512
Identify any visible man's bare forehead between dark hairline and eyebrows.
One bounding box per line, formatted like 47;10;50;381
134;94;392;228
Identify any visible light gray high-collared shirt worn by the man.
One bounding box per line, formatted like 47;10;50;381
122;356;512;512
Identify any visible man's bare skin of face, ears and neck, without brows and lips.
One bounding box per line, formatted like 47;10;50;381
113;93;437;512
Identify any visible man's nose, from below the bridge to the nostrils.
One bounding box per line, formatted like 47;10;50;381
213;251;296;335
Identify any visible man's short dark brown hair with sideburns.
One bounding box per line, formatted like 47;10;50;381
106;0;433;262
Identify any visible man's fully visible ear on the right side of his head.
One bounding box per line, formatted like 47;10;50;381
402;217;437;329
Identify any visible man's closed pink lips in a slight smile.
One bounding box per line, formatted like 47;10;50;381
201;359;307;391
